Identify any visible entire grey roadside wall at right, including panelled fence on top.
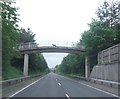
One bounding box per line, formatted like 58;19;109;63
89;43;120;82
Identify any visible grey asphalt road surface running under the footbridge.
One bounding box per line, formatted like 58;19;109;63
9;73;117;99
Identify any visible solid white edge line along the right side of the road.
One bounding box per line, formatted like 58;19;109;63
62;76;120;98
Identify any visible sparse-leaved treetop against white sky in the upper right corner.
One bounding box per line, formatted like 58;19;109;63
96;0;120;27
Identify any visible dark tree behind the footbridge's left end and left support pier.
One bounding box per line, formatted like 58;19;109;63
12;28;48;75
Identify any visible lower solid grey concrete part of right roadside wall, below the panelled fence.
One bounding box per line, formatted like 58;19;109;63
90;63;120;82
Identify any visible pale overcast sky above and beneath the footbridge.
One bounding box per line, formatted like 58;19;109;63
16;0;103;68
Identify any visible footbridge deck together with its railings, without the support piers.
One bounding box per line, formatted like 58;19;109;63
17;41;85;54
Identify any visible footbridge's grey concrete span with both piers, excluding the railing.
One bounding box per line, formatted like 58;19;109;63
18;45;90;78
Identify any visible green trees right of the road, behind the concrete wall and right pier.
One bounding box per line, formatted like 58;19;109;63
56;1;120;75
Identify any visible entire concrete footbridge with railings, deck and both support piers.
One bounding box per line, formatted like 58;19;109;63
16;41;90;78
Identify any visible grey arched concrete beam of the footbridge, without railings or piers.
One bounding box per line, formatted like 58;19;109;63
19;47;85;54
